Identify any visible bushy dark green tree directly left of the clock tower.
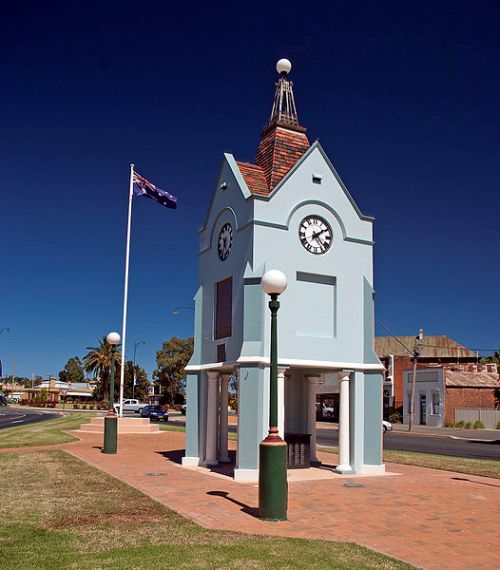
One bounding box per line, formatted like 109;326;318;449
153;336;193;404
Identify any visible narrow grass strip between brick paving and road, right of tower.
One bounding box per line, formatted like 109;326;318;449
318;446;500;479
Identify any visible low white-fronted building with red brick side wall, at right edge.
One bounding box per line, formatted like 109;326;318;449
403;363;500;428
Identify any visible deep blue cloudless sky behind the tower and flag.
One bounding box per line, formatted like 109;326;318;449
0;0;500;376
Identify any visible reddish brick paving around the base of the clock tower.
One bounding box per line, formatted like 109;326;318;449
63;432;500;570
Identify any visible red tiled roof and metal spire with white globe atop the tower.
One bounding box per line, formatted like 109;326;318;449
238;59;310;195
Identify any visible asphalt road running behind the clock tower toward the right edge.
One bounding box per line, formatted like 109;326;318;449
170;414;500;460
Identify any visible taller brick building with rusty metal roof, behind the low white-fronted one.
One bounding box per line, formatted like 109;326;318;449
375;335;478;415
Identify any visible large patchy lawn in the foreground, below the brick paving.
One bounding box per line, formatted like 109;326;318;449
0;450;412;570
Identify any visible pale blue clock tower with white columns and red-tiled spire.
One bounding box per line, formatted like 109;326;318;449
183;60;384;481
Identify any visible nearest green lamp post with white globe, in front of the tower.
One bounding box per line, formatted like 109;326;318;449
259;269;288;521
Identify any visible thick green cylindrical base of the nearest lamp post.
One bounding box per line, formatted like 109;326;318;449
259;435;288;521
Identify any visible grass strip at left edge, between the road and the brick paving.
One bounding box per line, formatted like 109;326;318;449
0;414;92;448
